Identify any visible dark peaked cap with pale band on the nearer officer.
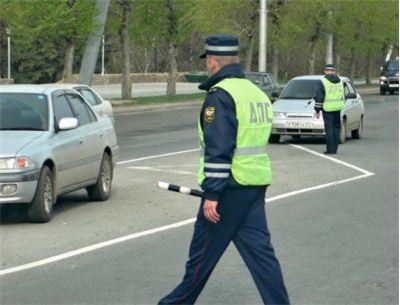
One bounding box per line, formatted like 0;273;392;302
200;35;239;58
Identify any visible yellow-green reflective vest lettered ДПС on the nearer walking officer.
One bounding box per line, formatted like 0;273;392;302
198;78;273;185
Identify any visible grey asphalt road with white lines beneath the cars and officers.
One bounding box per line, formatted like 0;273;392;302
0;94;399;305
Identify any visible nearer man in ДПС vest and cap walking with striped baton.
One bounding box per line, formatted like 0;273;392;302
159;35;289;304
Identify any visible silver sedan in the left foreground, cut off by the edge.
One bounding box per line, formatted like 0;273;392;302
0;85;119;222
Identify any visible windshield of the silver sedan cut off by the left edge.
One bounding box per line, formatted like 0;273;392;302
0;93;49;130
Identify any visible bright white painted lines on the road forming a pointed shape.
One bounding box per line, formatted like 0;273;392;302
0;144;374;276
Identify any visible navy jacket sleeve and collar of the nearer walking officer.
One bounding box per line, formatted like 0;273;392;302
199;64;245;200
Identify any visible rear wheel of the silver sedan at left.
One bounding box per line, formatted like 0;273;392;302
86;153;113;201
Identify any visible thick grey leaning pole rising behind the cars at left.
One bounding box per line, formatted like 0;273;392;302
79;0;110;86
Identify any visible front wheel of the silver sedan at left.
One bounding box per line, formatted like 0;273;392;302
28;165;55;222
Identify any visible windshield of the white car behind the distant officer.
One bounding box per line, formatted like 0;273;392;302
279;79;321;99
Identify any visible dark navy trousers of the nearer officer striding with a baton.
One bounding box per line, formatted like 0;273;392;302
159;187;289;304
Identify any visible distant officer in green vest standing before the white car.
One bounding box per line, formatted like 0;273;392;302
314;64;344;154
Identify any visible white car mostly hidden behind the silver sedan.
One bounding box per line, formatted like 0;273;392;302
41;83;114;119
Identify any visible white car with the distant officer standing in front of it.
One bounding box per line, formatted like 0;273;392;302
270;75;364;144
